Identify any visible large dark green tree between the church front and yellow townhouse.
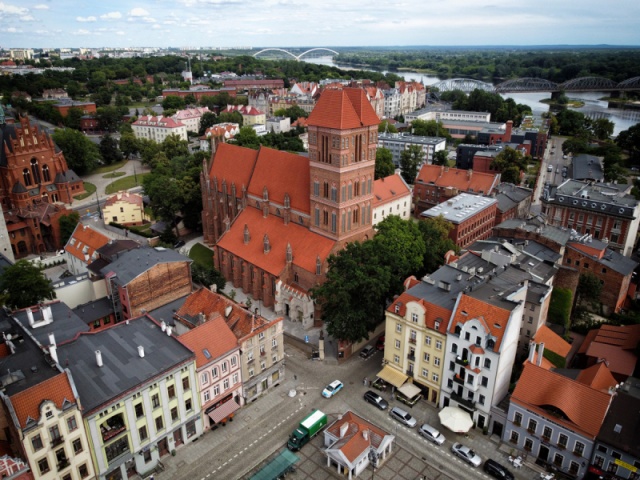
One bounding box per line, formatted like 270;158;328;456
311;241;391;342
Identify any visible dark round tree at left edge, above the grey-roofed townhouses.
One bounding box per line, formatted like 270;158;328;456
0;260;56;309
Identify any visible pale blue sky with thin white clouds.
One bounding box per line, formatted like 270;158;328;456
0;0;640;48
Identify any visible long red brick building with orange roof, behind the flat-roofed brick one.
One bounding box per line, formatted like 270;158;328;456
413;164;500;218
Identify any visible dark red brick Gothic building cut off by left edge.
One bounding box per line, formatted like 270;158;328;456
0;108;84;258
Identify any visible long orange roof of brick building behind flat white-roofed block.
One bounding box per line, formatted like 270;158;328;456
416;164;500;195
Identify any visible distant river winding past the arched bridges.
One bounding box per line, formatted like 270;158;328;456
303;57;640;136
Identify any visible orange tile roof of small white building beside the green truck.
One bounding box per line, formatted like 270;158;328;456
328;411;389;463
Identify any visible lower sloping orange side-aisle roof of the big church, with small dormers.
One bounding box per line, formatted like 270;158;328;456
218;207;335;276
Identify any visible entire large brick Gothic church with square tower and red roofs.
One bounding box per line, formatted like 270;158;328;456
201;88;380;328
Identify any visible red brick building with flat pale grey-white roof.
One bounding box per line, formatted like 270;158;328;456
421;193;498;248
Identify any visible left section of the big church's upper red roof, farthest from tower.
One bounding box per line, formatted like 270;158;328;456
209;143;262;197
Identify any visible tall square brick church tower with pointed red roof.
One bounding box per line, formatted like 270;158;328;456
307;88;380;246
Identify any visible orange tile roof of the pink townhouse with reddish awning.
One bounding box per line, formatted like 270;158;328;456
180;314;238;368
